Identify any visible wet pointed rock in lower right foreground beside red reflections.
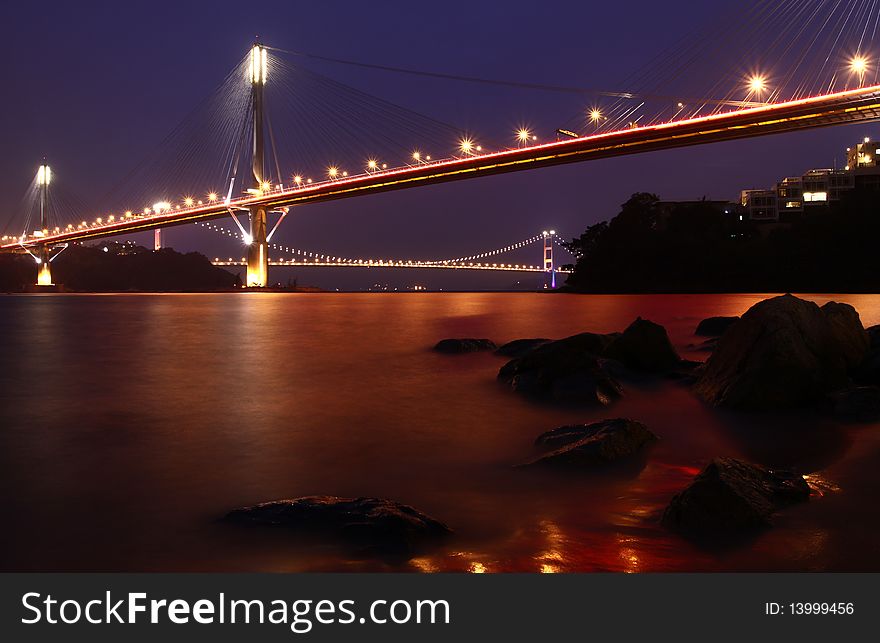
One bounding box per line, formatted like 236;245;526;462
662;458;810;534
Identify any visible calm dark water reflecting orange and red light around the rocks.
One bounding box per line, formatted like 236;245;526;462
0;293;880;572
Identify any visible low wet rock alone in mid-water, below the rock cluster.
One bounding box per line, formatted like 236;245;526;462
523;418;657;467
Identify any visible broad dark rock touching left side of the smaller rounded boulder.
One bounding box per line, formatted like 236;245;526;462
498;333;623;405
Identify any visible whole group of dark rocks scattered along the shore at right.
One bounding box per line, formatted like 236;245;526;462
227;295;880;553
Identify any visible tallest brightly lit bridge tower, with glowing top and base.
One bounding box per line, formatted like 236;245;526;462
246;43;269;288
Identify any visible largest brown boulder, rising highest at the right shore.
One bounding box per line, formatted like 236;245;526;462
695;295;868;410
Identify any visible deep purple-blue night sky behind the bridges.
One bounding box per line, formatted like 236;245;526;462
0;0;875;287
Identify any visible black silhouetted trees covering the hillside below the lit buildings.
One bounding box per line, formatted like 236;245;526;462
566;191;880;292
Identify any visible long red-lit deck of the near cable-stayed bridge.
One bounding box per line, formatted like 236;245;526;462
6;85;880;251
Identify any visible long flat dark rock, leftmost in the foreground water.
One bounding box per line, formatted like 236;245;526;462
226;496;452;552
